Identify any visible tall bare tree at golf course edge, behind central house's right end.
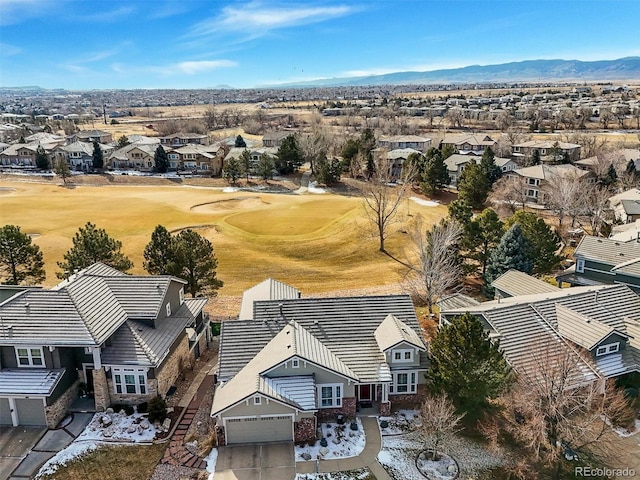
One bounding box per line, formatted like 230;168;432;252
404;220;462;313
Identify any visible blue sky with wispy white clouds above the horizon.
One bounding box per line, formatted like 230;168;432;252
0;0;640;89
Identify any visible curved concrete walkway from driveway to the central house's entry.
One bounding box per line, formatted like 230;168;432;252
296;417;391;480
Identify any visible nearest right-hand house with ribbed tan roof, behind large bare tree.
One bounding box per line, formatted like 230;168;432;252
440;285;640;384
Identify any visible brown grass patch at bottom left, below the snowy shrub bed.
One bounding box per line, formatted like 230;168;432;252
37;444;166;480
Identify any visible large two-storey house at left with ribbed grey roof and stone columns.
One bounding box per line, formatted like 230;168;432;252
0;263;210;428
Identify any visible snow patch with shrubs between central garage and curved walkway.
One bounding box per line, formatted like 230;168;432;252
295;418;366;461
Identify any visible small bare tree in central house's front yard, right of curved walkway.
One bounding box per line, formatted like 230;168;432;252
419;393;465;460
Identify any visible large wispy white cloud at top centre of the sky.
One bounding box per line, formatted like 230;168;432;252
193;1;357;37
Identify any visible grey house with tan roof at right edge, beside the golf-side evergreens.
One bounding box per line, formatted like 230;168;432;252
556;235;640;292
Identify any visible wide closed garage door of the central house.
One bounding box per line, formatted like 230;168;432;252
226;415;293;444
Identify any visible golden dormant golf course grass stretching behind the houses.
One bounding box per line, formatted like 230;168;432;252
0;181;446;296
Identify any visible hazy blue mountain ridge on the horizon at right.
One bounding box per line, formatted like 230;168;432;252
270;57;640;87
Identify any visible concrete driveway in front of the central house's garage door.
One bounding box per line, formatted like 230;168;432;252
215;442;296;480
